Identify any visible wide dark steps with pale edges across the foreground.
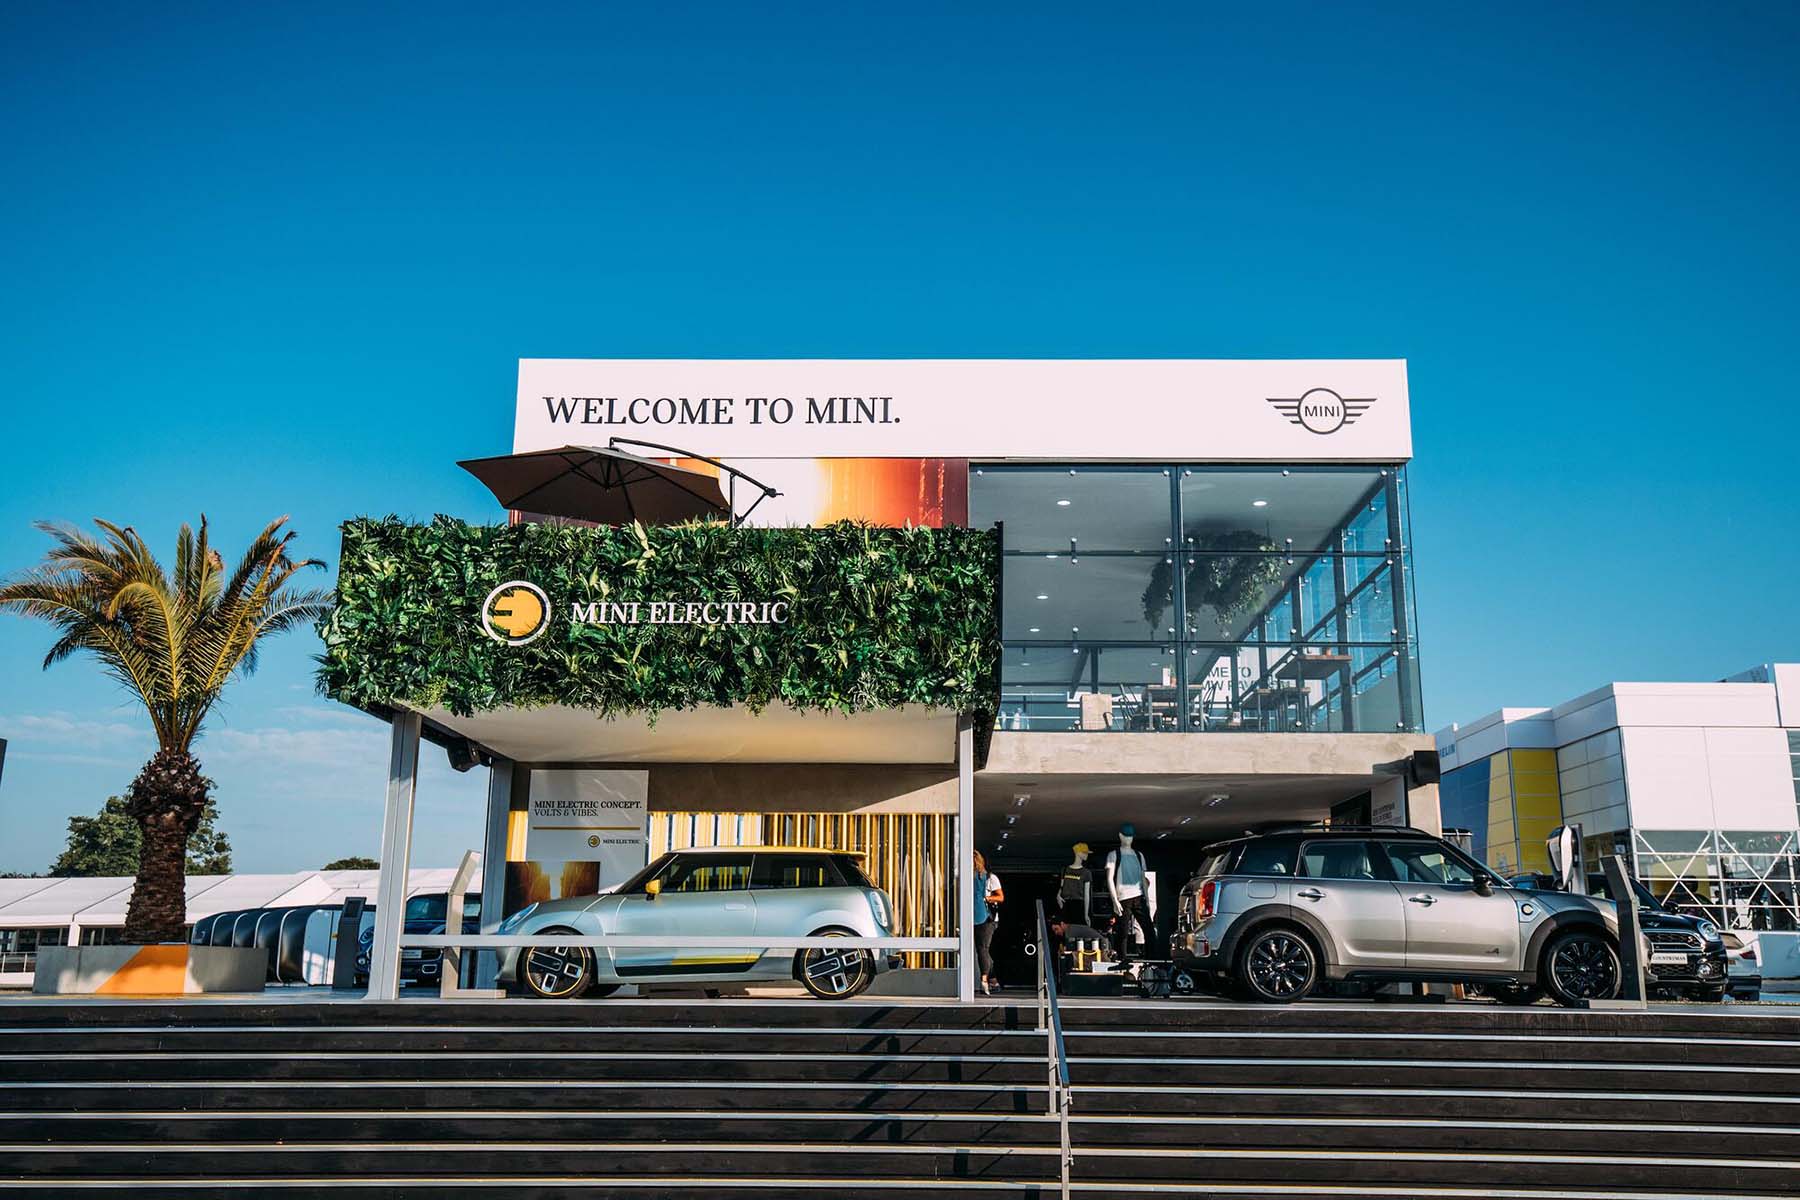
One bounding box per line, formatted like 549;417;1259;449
0;1000;1800;1200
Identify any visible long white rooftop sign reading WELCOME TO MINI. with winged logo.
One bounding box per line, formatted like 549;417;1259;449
513;358;1413;462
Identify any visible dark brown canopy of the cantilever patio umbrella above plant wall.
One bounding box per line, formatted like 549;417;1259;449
457;446;731;525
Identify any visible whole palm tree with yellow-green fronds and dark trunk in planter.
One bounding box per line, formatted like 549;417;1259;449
0;516;331;945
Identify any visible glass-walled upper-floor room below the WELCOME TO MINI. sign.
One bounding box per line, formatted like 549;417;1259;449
968;462;1424;732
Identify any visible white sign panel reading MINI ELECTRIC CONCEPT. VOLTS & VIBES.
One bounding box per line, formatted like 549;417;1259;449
526;770;650;889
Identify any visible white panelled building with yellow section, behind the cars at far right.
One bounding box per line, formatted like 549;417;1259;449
1436;662;1800;930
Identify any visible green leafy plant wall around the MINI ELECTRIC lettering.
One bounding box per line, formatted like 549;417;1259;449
319;516;999;716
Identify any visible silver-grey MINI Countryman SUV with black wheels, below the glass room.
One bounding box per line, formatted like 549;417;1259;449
1172;826;1620;1006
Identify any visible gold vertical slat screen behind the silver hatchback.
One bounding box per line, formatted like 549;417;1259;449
650;813;956;968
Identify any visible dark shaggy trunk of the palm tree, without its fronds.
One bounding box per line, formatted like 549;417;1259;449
122;750;211;946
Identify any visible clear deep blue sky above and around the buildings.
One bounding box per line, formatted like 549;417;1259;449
0;2;1800;871
